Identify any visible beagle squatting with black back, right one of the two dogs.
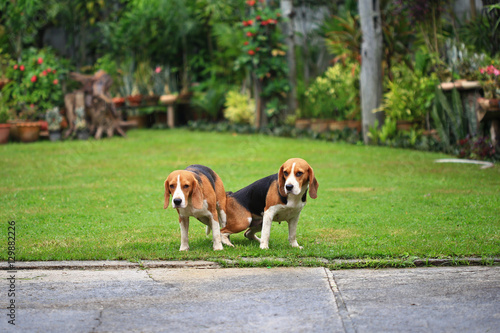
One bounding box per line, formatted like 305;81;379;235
221;158;318;249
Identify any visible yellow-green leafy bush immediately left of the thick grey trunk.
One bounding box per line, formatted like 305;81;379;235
302;62;359;120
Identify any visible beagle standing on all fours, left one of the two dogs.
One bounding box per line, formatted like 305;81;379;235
163;164;226;251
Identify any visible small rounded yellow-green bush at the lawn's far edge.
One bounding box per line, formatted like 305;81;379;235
224;90;255;125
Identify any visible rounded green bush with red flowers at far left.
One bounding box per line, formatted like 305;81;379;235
2;48;68;120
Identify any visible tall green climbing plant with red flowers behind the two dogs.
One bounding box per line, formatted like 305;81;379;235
236;0;290;120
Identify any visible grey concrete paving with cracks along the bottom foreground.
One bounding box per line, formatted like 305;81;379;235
0;263;500;333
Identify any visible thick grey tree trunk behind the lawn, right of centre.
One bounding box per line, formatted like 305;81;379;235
358;0;384;144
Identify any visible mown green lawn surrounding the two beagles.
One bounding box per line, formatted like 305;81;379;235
0;129;500;265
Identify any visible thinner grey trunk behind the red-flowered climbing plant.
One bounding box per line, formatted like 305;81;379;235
281;0;297;119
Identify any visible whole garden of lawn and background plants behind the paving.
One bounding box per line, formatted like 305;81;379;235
0;0;500;264
